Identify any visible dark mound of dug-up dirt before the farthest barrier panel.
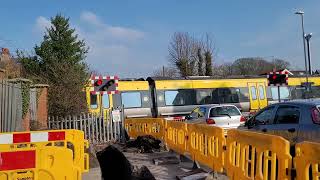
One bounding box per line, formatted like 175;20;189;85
126;135;161;153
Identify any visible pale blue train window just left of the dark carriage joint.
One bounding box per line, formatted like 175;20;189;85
121;92;141;108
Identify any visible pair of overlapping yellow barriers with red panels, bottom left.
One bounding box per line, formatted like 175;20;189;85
0;130;89;180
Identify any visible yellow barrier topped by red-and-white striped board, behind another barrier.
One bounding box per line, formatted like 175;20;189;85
0;130;89;172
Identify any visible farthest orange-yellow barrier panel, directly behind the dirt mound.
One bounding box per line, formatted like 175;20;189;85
125;118;164;139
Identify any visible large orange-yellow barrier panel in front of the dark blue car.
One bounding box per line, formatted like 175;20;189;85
225;130;292;180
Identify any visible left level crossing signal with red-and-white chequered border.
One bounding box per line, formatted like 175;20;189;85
91;76;119;94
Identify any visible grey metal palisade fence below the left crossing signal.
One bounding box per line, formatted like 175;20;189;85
48;107;125;144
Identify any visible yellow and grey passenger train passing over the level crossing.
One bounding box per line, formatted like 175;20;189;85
86;77;320;117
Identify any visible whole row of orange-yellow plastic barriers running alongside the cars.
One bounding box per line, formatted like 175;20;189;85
125;118;320;180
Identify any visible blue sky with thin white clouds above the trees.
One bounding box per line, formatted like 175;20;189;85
0;0;320;77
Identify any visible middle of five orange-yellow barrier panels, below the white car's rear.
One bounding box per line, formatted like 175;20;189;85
188;124;226;172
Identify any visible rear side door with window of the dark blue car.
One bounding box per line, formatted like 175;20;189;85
267;105;302;144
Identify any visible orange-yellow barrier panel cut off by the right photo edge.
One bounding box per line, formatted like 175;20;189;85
294;142;320;180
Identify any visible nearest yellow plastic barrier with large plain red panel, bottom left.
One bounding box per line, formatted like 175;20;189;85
0;146;81;180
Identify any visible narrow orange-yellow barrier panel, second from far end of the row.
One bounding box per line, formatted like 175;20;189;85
165;121;188;154
